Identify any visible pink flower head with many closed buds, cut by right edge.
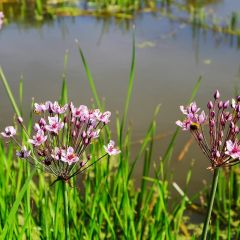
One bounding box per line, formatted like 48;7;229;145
176;90;240;169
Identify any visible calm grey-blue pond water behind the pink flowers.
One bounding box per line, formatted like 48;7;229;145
0;0;240;196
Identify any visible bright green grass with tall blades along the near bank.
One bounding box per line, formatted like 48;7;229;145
0;40;240;240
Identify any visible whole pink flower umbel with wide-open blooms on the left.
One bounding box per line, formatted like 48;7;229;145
1;101;120;182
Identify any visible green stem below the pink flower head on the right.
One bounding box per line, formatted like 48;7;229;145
202;168;219;240
